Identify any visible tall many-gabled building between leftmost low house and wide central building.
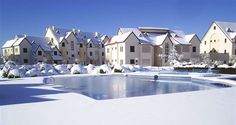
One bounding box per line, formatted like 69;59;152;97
45;26;108;65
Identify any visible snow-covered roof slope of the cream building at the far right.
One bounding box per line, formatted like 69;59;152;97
215;21;236;39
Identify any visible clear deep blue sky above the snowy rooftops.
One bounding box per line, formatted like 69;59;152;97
0;0;236;46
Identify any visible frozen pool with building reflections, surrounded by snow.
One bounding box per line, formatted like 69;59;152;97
48;75;229;100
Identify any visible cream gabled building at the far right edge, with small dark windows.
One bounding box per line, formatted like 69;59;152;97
200;21;236;63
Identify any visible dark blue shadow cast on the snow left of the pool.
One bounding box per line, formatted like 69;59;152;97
0;84;66;106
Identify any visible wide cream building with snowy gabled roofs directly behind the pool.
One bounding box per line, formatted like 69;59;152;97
105;27;200;66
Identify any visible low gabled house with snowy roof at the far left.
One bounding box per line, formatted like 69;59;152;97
2;35;56;64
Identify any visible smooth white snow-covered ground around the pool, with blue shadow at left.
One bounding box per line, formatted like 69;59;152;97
0;73;236;125
